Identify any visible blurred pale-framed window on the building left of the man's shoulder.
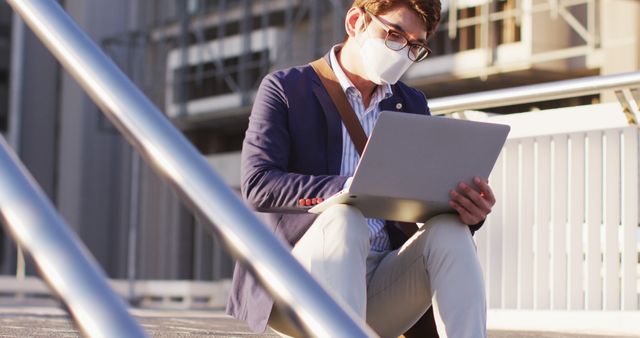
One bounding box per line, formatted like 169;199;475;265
165;27;280;117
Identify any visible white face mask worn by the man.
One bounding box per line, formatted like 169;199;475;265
360;30;413;85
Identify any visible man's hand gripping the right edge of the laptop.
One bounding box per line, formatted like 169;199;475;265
449;177;496;225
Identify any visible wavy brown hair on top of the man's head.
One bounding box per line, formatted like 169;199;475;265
351;0;441;37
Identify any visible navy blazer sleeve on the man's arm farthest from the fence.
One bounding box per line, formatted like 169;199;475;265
241;74;347;212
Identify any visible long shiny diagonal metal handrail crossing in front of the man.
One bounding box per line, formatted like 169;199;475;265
7;0;376;337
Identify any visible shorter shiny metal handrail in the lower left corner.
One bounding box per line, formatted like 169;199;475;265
0;136;145;337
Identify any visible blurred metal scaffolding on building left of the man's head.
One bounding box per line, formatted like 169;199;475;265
102;0;350;118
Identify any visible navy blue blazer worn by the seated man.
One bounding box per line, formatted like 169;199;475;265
227;56;429;332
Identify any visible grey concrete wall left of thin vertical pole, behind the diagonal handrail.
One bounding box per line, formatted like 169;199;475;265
43;0;135;277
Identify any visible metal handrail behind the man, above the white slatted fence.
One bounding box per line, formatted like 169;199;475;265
429;72;640;115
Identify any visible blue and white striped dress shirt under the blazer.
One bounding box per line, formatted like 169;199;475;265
330;45;393;252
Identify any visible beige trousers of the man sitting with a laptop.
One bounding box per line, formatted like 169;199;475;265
269;205;486;338
